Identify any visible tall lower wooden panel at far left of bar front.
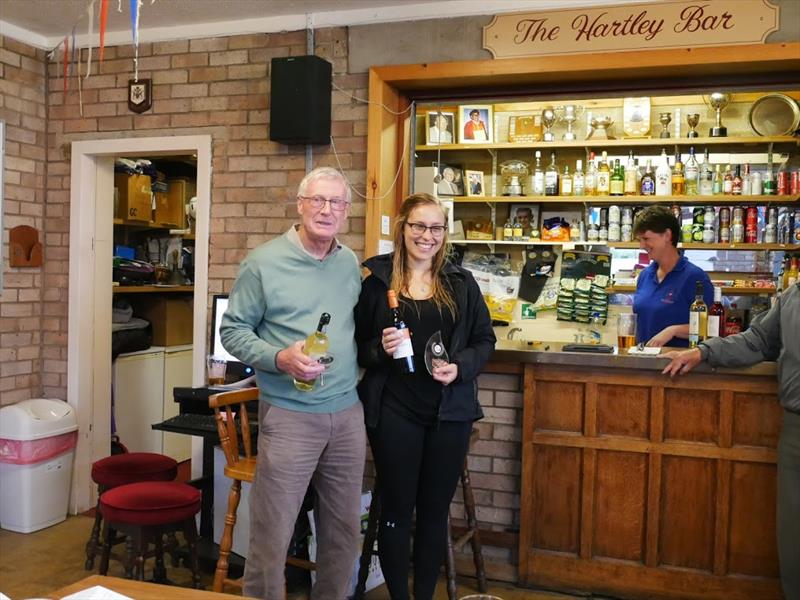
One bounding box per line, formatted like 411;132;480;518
526;446;581;554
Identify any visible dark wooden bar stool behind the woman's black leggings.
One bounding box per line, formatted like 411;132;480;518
353;429;489;600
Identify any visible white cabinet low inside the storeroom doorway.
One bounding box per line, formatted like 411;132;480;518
113;346;192;462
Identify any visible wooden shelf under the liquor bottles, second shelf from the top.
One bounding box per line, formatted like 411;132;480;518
454;194;800;206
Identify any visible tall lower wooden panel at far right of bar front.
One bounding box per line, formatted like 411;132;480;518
728;463;780;577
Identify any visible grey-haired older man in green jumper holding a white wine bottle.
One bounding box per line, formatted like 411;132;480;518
220;167;366;600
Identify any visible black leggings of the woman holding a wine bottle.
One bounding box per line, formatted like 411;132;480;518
367;407;472;600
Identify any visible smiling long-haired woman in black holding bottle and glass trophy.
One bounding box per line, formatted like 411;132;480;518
356;194;495;600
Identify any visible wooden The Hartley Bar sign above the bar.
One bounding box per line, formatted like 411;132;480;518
483;0;779;58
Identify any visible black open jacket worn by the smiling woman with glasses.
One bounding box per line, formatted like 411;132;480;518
356;254;496;427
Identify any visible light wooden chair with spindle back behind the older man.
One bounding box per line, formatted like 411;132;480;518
208;388;316;592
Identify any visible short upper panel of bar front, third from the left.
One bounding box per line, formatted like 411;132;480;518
664;388;719;444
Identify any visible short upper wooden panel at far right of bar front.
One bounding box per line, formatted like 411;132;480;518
733;393;783;448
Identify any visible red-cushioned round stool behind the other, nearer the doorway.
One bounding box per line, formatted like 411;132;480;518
84;452;178;571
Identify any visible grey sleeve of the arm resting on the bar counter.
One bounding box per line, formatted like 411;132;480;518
699;298;781;367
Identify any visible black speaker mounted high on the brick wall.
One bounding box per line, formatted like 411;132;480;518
269;55;333;144
